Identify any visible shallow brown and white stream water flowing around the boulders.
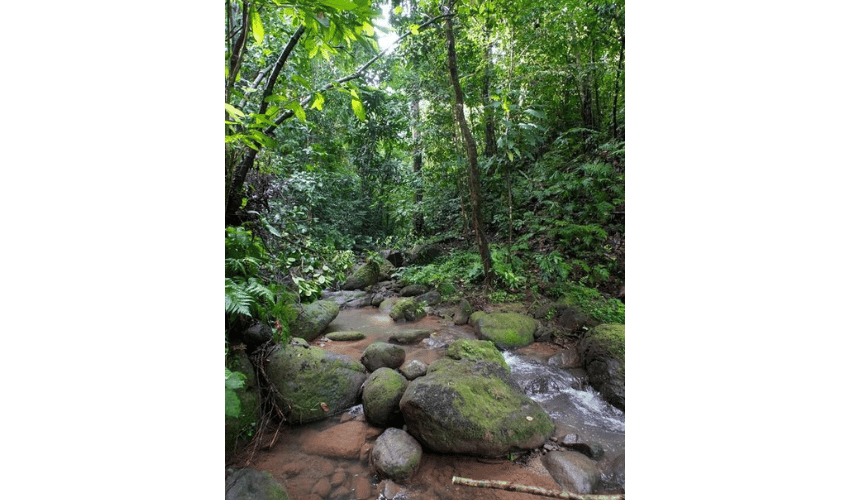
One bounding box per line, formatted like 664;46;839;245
232;308;625;500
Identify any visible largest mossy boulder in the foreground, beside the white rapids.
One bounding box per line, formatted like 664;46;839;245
400;340;555;457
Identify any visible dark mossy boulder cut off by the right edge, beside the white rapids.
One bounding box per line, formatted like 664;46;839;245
578;323;626;411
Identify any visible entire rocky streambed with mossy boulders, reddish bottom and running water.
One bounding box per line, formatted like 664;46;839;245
226;295;625;500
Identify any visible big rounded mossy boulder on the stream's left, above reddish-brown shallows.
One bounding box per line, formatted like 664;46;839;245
266;339;368;424
